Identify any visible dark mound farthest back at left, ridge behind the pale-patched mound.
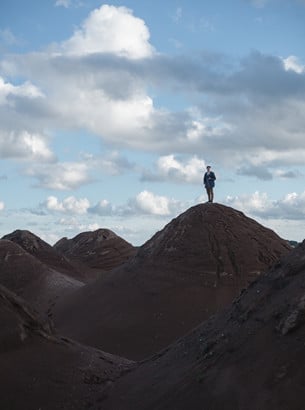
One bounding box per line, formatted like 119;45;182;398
2;229;83;280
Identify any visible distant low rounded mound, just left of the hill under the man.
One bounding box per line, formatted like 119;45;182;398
54;229;136;271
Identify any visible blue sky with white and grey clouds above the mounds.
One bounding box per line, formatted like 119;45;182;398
0;0;305;245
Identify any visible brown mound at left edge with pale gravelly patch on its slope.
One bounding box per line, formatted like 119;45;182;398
0;239;83;312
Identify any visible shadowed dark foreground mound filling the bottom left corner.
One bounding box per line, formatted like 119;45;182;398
0;285;132;410
